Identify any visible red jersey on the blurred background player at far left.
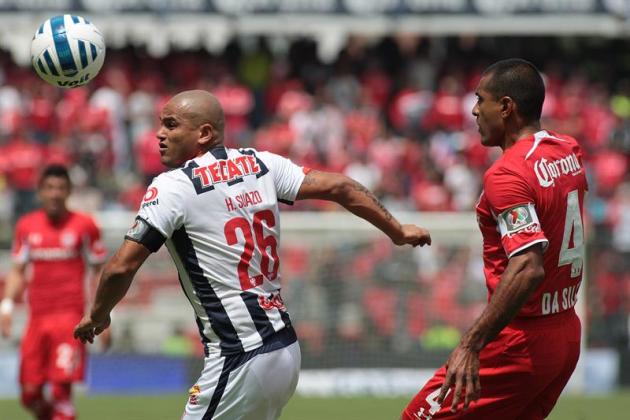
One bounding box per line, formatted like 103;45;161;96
12;210;106;316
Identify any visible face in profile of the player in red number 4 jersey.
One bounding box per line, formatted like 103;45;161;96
472;75;505;147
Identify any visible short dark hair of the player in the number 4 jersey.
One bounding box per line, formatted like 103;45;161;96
483;58;545;122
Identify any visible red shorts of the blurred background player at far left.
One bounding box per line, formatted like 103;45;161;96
20;313;85;385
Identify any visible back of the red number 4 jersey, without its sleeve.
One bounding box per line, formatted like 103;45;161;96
501;130;588;316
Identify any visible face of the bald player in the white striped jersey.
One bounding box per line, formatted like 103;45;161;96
156;102;199;168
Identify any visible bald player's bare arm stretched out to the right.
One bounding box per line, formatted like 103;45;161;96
296;170;431;246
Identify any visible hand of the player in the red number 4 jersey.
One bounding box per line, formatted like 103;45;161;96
437;343;481;412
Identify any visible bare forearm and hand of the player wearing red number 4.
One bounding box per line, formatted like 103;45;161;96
438;244;545;411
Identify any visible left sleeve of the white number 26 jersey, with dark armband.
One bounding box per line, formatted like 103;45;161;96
125;176;186;252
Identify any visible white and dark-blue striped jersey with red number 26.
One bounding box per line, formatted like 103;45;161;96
126;147;305;355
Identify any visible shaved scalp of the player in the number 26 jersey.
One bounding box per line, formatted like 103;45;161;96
167;90;225;142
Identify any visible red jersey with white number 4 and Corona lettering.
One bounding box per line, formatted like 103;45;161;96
476;130;588;317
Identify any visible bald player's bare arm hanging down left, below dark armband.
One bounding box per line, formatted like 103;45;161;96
74;240;151;343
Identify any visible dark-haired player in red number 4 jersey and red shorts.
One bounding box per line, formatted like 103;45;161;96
402;59;587;420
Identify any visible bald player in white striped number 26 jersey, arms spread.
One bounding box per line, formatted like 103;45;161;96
75;91;431;420
